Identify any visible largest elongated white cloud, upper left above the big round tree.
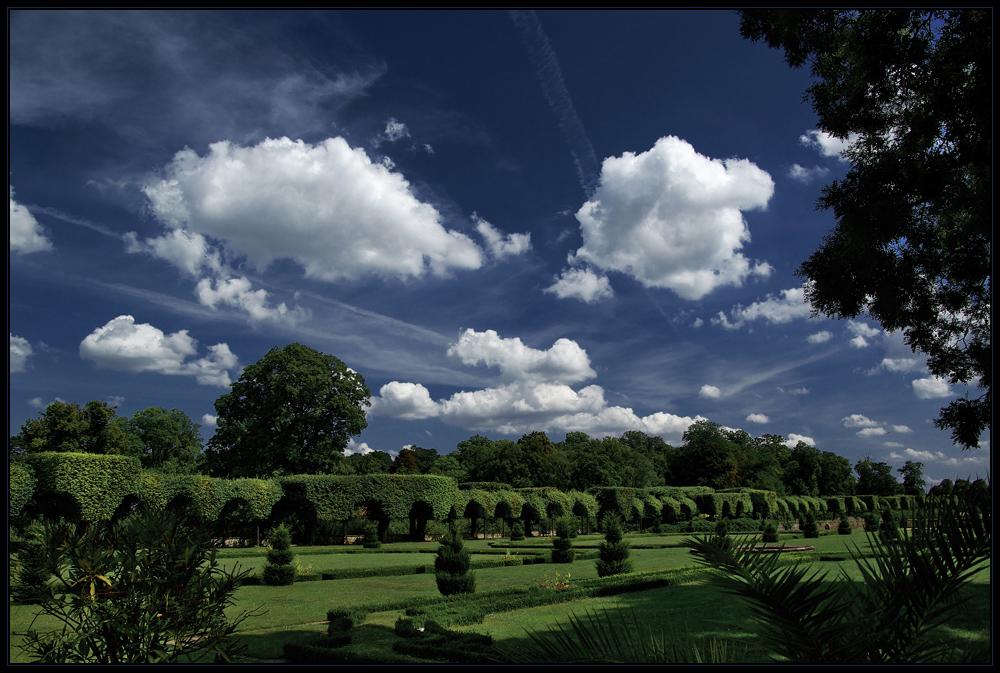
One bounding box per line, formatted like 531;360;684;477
144;137;482;281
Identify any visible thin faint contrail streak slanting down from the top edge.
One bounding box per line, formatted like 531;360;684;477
510;10;600;198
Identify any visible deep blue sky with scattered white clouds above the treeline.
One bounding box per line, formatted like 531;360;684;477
8;11;990;481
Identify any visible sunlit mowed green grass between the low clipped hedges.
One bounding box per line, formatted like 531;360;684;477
10;532;991;663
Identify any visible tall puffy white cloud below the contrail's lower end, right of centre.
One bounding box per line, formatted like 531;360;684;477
575;136;774;299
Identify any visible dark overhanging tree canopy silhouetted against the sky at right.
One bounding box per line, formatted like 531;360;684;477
740;9;993;448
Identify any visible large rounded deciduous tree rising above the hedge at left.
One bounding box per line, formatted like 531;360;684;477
207;343;371;477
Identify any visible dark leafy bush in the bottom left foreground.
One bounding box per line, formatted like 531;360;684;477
11;511;255;664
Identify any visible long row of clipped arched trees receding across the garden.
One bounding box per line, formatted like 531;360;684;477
9;453;948;539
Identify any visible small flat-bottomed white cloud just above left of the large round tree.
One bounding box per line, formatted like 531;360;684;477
80;315;239;387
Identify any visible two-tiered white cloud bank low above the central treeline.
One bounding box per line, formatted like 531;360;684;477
371;329;701;440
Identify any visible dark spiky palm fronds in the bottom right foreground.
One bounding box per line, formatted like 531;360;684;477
687;486;993;664
